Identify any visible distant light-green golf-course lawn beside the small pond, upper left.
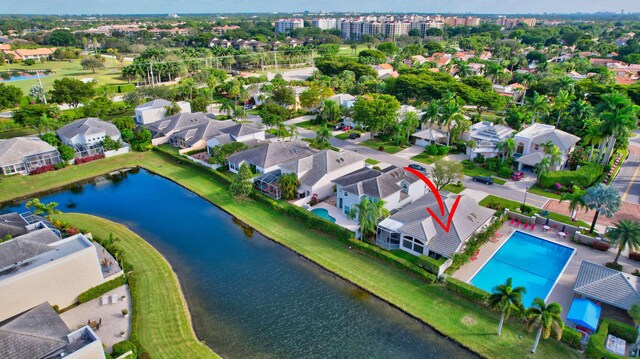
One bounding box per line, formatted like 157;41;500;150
0;58;128;94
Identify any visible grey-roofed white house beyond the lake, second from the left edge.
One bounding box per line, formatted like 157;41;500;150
56;118;120;147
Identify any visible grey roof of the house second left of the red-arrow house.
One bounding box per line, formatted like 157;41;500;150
282;150;365;187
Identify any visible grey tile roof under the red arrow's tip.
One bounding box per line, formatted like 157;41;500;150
380;193;495;257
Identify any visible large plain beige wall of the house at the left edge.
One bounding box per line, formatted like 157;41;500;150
0;239;104;321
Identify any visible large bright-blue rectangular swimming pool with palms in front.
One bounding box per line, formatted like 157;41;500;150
470;231;574;307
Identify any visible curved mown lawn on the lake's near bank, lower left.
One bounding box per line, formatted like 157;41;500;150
56;213;218;358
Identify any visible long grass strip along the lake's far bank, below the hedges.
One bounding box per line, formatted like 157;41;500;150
0;152;580;358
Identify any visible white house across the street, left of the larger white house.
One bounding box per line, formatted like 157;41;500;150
463;121;515;159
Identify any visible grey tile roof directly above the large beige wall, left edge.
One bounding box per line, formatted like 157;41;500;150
0;228;60;269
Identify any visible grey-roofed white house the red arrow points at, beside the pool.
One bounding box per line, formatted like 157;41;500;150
376;195;495;259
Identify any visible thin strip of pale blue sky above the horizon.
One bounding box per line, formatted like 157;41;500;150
0;0;640;15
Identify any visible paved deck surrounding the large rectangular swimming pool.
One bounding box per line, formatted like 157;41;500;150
453;222;639;319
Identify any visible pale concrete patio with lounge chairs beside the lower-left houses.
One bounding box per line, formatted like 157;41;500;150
60;285;131;352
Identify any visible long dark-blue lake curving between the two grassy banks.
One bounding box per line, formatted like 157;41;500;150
2;170;475;359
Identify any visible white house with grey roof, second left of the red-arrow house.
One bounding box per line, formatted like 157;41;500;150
280;150;365;200
